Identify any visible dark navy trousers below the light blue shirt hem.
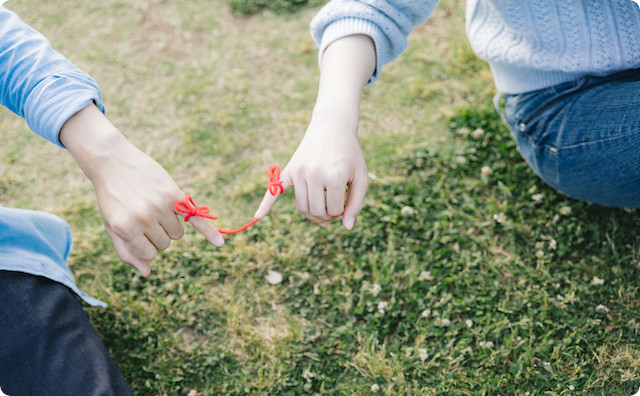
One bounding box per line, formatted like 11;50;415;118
0;271;132;396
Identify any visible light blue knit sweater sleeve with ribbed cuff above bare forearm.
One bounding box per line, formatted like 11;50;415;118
310;0;439;85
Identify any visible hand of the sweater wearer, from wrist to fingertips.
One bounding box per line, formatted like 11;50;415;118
255;111;369;230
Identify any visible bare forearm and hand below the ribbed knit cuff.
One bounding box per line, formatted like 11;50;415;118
255;35;376;230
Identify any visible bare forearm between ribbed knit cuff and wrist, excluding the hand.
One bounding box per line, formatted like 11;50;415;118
313;35;376;130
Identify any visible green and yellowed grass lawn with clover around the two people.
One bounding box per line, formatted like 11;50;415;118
0;0;640;396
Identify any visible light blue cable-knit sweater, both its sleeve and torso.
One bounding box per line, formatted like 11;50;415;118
311;0;640;93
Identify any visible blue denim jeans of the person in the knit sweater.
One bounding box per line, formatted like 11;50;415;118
504;69;640;208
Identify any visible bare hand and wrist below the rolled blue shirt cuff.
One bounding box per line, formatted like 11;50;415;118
59;104;224;276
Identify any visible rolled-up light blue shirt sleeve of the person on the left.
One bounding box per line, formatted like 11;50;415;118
0;6;104;146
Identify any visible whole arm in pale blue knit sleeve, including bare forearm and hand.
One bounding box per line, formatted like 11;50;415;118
256;0;438;229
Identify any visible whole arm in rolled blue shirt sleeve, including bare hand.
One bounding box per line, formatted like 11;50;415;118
0;7;224;276
